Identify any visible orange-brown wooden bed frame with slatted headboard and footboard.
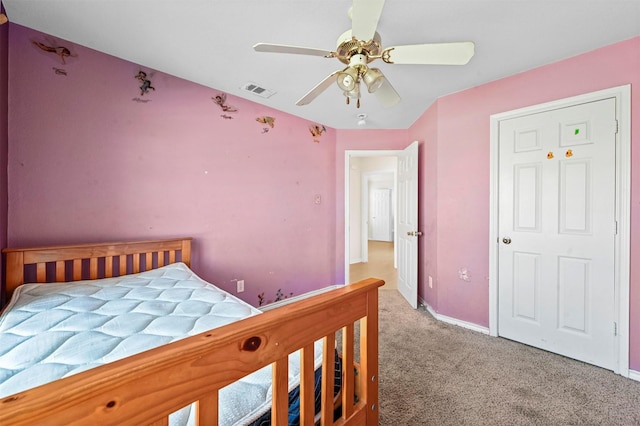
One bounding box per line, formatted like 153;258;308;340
0;238;384;425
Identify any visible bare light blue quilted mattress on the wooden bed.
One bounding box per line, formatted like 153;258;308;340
0;263;322;425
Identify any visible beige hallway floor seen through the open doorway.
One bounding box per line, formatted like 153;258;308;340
349;241;398;290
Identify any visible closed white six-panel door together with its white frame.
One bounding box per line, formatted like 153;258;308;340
489;86;630;376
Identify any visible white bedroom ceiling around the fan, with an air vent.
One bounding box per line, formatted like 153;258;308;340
2;0;640;129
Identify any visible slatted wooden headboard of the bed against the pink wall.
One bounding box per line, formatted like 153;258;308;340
2;237;192;300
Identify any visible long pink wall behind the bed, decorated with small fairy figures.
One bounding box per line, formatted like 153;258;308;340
5;24;336;304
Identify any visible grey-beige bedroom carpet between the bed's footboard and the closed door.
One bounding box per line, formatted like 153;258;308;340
379;289;640;426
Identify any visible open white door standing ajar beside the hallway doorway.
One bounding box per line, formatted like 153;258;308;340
397;141;422;309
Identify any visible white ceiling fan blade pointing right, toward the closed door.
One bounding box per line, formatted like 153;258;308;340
383;41;475;65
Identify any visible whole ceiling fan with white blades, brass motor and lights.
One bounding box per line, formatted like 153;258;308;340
253;0;474;108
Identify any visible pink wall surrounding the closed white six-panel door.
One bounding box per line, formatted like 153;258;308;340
409;37;640;370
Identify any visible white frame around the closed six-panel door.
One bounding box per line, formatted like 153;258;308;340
489;85;631;377
